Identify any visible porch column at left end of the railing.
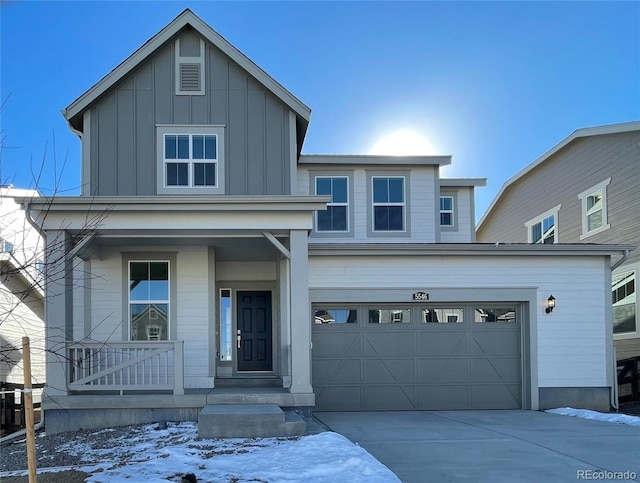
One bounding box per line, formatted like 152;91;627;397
44;230;73;396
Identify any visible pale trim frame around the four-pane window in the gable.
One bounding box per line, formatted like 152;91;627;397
156;124;225;195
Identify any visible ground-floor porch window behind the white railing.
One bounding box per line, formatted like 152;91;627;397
129;261;169;340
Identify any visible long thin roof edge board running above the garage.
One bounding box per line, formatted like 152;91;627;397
309;243;635;257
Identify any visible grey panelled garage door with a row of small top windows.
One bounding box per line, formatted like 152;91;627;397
313;304;522;411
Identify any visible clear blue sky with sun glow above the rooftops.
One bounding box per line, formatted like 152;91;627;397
0;0;640;219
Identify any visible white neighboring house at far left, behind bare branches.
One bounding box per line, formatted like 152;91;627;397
0;186;45;410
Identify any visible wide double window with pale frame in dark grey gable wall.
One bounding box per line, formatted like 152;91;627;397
157;126;224;194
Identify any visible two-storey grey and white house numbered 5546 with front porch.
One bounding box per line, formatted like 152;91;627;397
18;10;628;432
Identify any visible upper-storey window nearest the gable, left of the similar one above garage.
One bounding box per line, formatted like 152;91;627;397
316;176;349;232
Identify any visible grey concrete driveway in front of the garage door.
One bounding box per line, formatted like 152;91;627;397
314;411;640;483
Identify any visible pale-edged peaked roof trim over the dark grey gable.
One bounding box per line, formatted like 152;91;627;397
62;8;311;147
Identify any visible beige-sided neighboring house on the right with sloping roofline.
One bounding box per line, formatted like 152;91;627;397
477;122;640;360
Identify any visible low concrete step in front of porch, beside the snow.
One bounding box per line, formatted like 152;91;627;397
198;404;307;438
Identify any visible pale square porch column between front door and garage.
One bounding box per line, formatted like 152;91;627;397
289;230;313;393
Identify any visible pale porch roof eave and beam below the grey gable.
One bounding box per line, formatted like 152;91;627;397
18;196;330;233
